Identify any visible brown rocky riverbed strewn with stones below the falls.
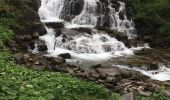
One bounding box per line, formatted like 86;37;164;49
10;40;170;96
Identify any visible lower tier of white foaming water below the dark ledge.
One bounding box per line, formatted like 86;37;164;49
40;28;133;60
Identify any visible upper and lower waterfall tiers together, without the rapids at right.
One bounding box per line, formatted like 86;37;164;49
39;0;133;56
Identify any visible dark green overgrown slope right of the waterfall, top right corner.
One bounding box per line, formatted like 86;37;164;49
131;0;170;37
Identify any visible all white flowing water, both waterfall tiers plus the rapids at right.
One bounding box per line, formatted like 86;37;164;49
39;0;170;81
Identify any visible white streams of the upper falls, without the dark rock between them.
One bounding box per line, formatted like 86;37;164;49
39;0;136;38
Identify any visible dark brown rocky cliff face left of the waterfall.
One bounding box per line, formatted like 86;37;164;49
4;0;47;50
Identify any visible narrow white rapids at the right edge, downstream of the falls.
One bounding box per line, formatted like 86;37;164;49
113;65;170;81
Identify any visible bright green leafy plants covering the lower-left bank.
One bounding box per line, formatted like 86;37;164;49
0;51;115;100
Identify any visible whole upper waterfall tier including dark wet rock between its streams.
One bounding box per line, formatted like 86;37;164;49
39;0;136;37
